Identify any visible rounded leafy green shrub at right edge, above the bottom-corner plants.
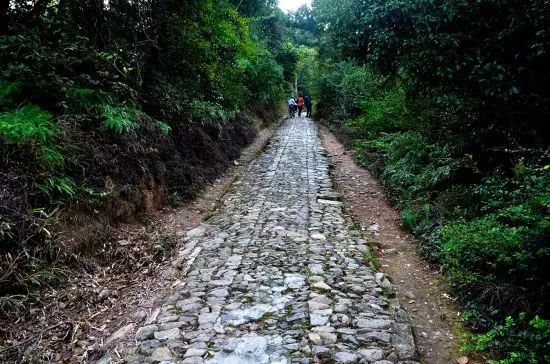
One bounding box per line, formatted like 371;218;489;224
440;214;550;324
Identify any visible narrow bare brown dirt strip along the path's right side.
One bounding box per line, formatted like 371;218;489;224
320;127;470;364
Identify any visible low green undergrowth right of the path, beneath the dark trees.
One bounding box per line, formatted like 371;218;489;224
320;59;550;364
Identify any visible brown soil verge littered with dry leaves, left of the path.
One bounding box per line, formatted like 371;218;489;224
0;123;278;363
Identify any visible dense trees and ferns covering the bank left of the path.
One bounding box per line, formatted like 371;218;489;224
0;0;292;310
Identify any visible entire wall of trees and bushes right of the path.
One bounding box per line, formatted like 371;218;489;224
314;0;550;363
